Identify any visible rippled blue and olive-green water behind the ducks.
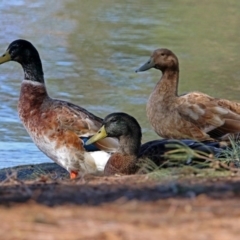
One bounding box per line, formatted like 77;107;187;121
0;0;240;168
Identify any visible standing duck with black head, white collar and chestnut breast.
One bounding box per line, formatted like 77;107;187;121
0;39;119;179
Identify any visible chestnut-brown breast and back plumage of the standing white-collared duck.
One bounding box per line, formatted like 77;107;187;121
18;83;118;151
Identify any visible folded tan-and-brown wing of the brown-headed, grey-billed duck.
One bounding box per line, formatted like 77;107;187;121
177;92;240;138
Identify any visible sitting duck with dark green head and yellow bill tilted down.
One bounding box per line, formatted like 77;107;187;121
86;112;224;175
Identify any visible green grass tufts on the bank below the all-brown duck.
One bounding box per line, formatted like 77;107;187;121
140;139;240;179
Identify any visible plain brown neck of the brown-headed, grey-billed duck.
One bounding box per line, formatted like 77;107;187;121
155;69;179;97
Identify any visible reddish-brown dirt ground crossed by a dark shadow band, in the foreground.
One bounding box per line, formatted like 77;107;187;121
0;165;240;240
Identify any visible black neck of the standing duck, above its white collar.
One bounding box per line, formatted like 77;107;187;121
21;56;44;84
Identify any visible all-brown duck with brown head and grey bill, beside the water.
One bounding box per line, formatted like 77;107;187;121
136;49;240;141
